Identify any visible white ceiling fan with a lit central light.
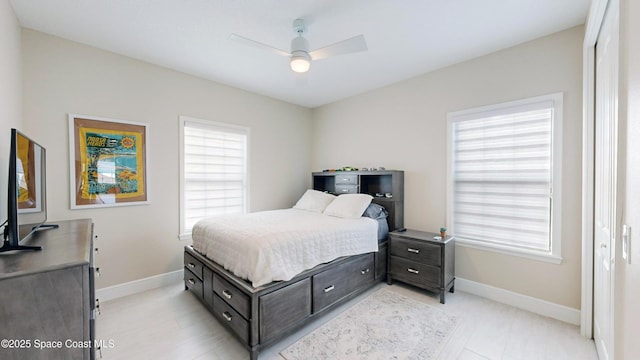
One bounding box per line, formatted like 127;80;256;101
229;19;367;73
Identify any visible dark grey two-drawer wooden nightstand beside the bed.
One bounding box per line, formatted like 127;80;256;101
387;230;455;304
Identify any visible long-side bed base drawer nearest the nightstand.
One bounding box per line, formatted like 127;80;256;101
313;254;375;313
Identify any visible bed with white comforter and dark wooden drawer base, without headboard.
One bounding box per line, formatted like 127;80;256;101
184;173;404;359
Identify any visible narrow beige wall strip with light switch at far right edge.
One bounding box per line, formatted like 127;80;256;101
614;0;640;359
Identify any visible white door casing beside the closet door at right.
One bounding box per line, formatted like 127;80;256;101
580;0;619;344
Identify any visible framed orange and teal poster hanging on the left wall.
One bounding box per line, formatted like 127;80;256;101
69;114;149;209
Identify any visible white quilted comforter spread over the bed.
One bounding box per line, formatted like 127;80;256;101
192;209;378;287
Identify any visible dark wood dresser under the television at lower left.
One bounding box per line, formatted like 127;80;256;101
0;219;96;360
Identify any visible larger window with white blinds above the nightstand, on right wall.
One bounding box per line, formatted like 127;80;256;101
448;94;562;263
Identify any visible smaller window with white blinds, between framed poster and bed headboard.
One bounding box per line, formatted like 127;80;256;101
180;116;249;240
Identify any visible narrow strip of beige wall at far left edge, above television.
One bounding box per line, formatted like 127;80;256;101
0;0;22;223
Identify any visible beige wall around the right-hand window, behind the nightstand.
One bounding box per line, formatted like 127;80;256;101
312;27;584;309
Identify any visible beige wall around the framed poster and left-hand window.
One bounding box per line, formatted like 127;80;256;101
22;30;311;288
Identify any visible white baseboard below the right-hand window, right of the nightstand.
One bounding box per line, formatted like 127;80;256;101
455;277;580;326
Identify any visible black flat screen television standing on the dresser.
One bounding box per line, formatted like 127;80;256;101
0;129;54;252
